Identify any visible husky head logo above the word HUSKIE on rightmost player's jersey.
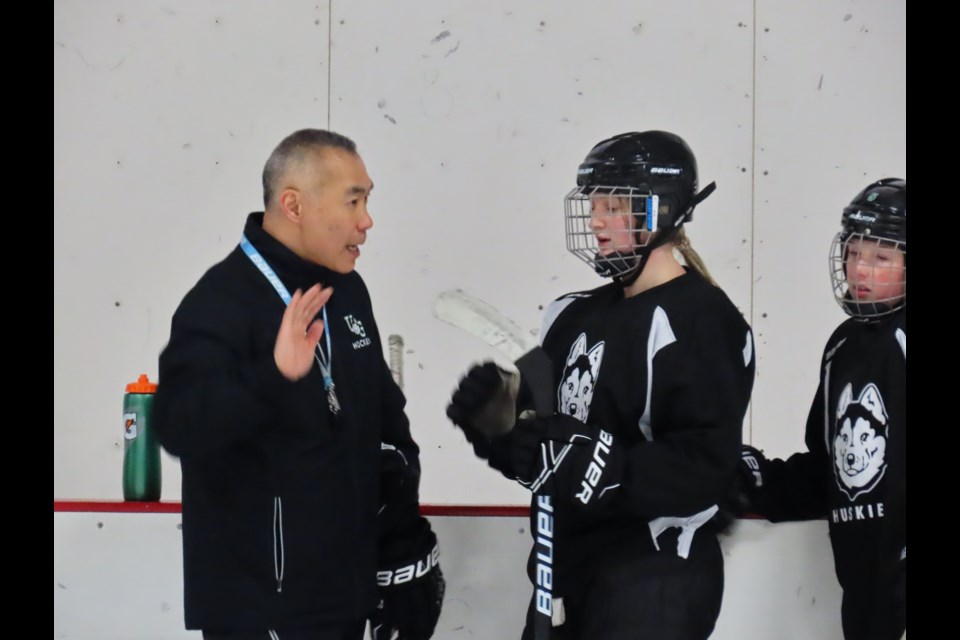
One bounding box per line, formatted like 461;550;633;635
833;383;888;500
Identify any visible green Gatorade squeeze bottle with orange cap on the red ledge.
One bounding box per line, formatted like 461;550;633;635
123;373;160;502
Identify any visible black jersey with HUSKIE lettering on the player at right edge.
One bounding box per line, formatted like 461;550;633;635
754;308;907;638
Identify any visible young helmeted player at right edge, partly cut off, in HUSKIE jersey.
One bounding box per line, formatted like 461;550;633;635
743;178;907;640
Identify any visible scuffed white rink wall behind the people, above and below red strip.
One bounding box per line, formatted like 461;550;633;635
53;0;906;639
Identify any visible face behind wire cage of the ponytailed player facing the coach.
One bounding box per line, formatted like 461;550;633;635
563;186;658;272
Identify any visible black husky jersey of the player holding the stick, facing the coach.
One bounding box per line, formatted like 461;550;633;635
541;270;755;595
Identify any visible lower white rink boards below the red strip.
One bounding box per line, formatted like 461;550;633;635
53;513;842;640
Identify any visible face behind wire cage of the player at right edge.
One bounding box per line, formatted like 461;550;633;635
830;232;907;319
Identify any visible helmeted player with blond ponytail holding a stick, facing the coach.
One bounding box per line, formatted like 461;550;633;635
448;131;754;640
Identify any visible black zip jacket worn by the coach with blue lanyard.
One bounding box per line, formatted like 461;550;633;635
154;213;419;629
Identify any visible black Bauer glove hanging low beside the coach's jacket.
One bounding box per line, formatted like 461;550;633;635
370;517;446;640
